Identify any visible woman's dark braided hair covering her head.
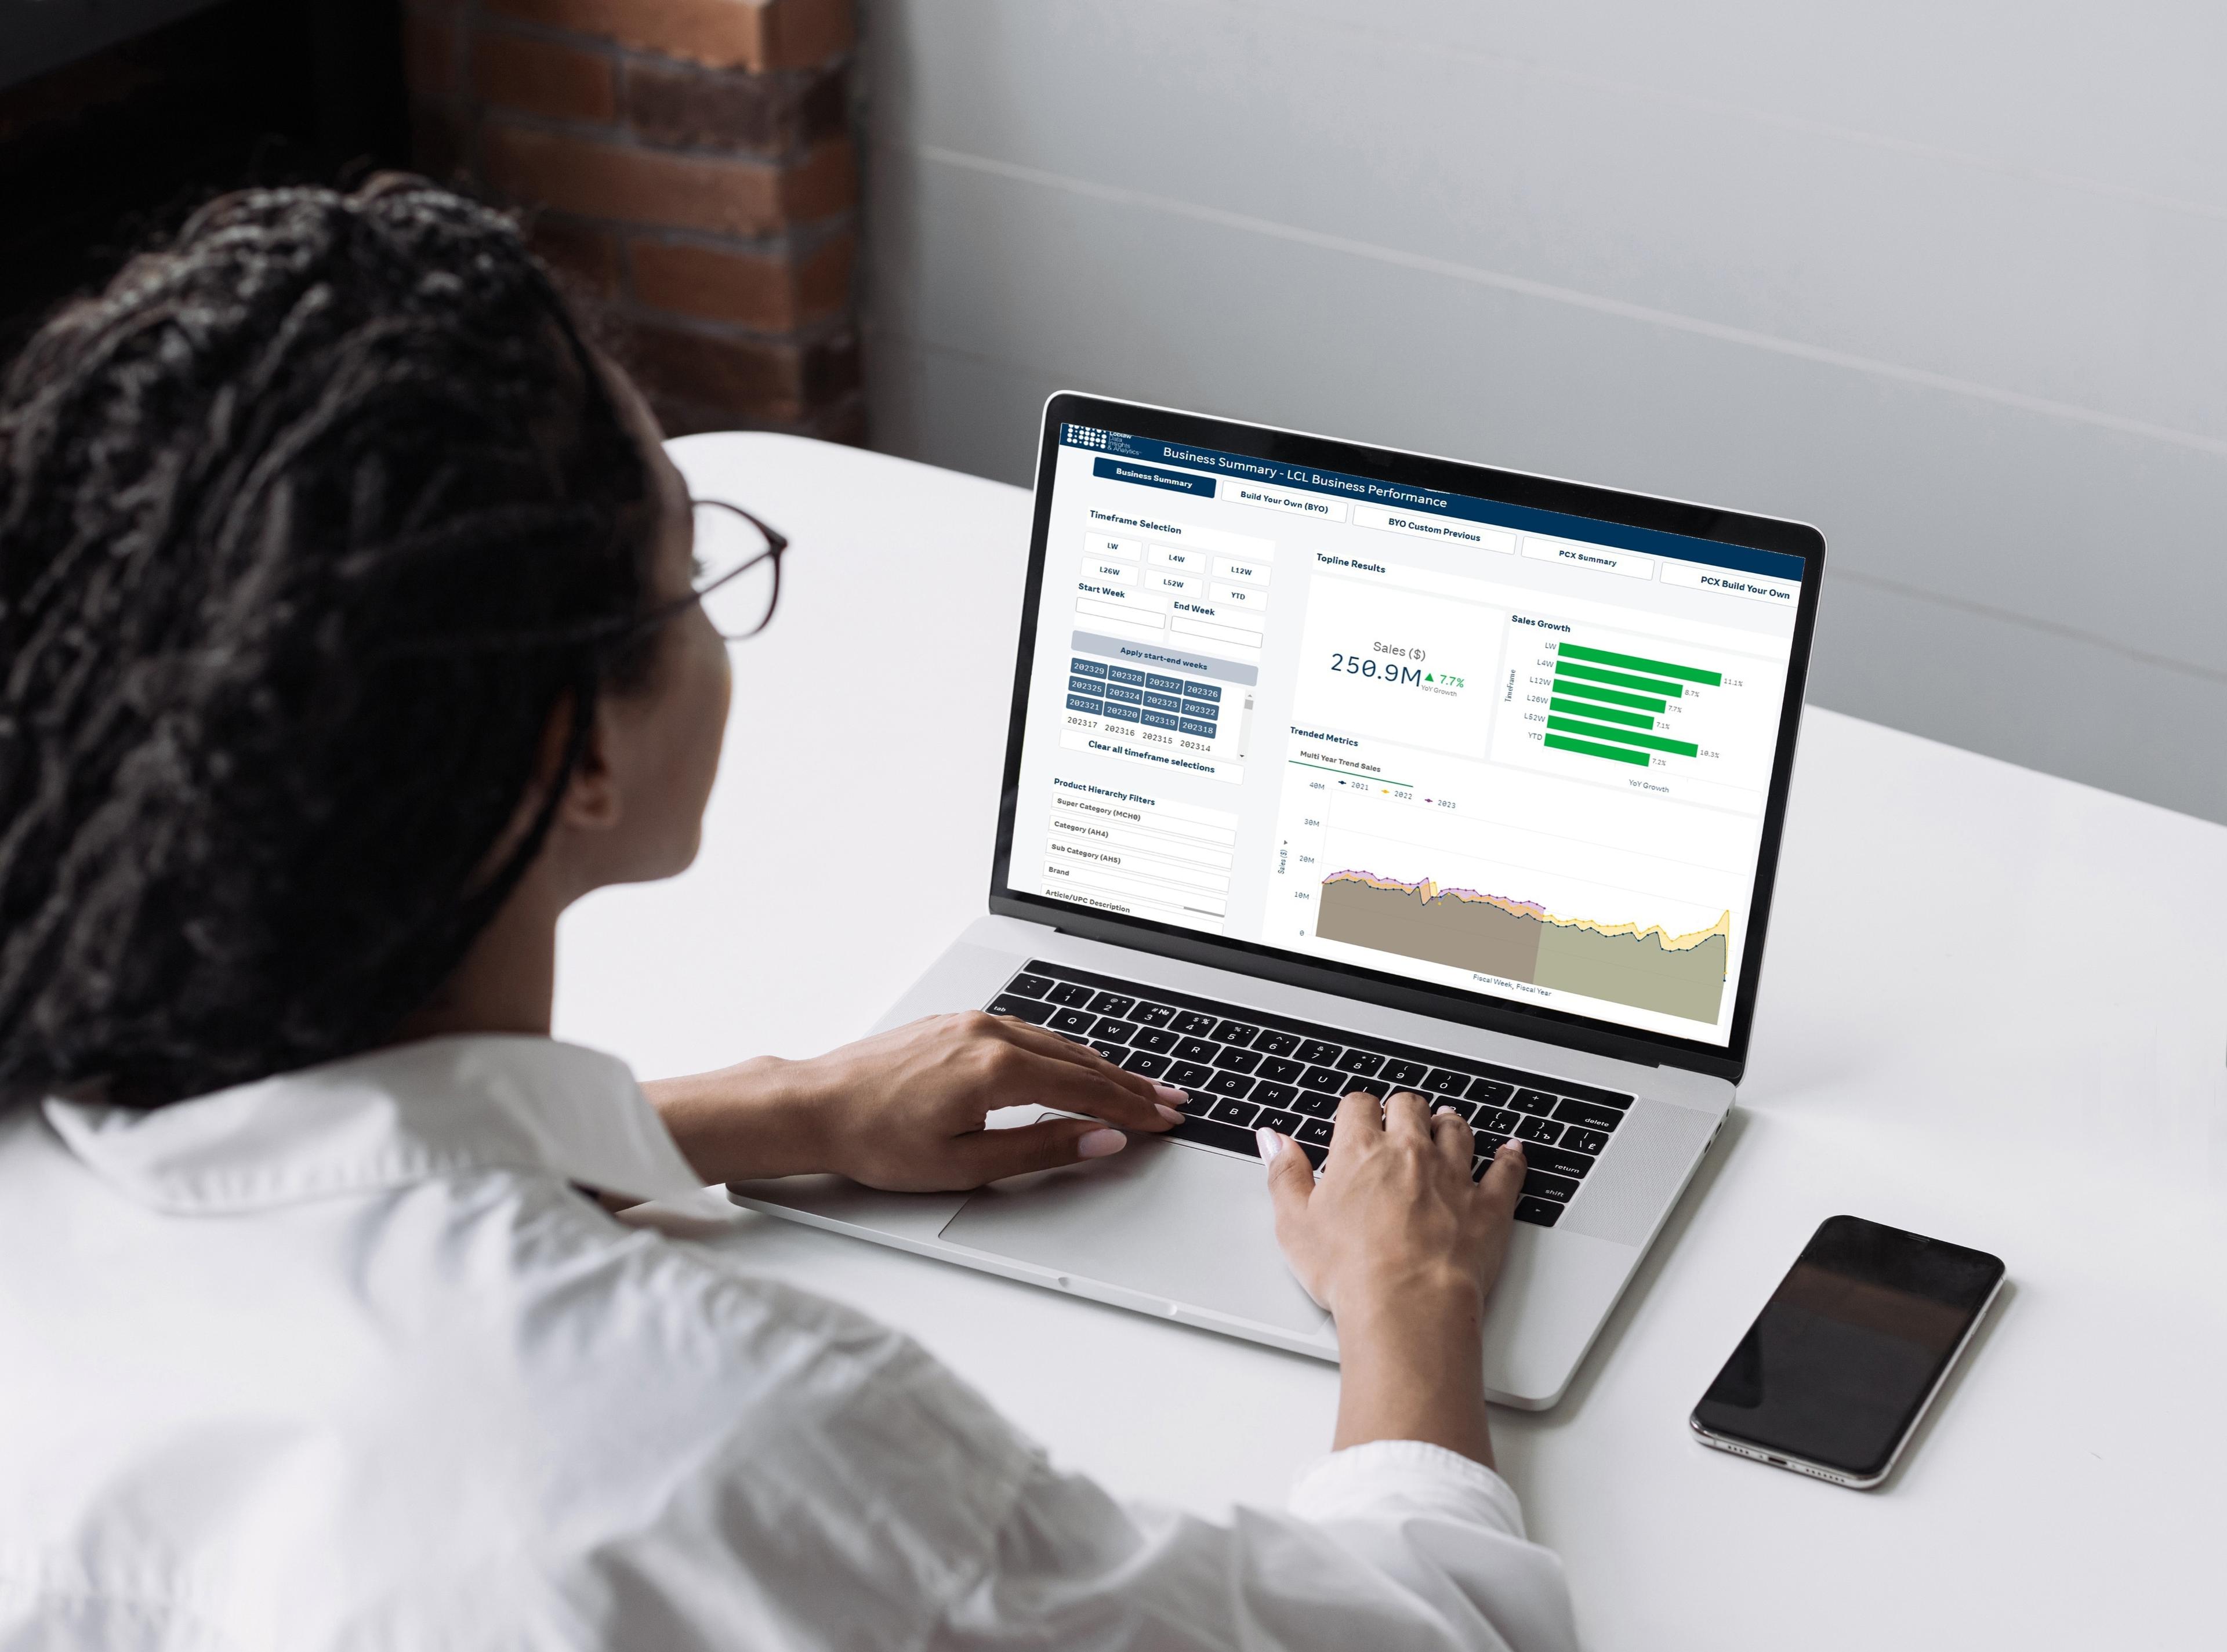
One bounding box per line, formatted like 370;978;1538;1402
0;176;655;1106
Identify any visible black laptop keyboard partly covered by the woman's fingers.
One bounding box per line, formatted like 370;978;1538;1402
986;960;1633;1227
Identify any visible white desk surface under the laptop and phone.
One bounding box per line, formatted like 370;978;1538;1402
557;437;2227;1652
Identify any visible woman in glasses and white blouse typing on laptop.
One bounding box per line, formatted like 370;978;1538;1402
0;180;1572;1652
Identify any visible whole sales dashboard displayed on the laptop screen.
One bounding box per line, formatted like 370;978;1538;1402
1007;425;1804;1047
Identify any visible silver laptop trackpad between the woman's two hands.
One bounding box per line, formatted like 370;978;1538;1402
940;1135;1329;1336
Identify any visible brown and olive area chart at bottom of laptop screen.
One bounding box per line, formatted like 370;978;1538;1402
1314;870;1733;1022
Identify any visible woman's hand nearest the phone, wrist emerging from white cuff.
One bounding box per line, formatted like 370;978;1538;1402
1260;1091;1524;1465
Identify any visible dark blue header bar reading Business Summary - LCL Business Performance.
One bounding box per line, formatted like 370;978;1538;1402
1060;425;1802;583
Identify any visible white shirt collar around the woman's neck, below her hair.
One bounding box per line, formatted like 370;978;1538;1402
45;1033;702;1214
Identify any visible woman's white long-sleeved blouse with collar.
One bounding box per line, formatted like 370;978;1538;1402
0;1037;1575;1652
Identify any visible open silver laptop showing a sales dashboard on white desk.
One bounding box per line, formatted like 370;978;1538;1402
731;394;1824;1409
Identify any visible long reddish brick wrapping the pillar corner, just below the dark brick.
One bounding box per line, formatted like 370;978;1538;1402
481;120;857;236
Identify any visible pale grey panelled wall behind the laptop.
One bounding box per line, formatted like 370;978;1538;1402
866;0;2227;819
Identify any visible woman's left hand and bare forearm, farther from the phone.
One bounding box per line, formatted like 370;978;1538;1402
644;1011;1183;1191
